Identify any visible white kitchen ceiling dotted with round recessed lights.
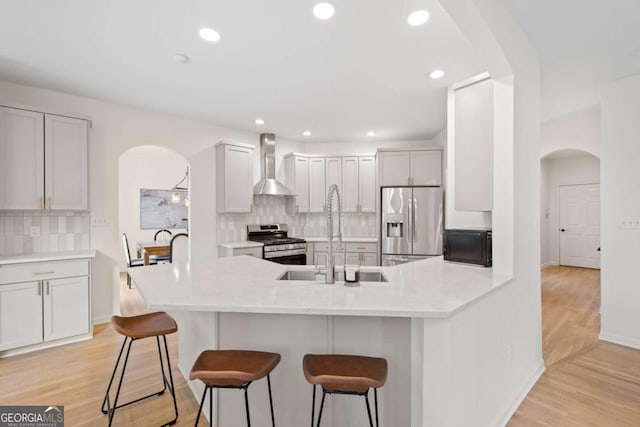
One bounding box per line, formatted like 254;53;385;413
0;0;484;141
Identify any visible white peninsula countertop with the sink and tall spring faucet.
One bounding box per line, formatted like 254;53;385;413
128;256;512;317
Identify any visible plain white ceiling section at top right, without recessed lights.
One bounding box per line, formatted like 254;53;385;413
504;0;640;119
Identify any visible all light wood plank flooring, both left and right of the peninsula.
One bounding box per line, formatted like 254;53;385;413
0;267;640;427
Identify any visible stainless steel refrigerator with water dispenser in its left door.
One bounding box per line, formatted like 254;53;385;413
380;187;443;265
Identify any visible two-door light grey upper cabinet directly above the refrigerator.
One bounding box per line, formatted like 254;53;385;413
378;149;442;187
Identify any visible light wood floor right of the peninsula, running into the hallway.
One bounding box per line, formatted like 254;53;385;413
508;267;640;427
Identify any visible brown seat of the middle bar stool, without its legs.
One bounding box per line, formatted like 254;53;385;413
189;350;280;387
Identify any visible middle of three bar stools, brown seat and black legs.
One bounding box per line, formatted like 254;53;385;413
189;350;280;427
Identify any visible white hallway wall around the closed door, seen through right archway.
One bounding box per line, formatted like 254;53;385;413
540;154;600;266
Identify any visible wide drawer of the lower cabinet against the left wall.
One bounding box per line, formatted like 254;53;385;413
0;260;89;284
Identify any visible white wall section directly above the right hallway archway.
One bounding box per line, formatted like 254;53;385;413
541;105;600;157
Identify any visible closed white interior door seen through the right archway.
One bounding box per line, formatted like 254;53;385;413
559;184;600;268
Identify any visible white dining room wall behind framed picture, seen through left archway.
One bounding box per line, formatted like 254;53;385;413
118;145;189;269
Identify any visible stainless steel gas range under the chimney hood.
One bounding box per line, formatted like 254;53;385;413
247;224;307;265
